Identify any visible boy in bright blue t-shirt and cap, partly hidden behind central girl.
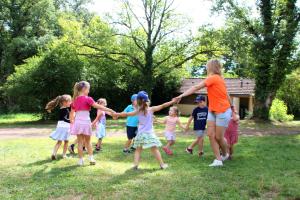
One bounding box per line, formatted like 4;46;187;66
123;94;139;153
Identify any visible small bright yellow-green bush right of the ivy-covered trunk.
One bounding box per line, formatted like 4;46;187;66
270;99;294;122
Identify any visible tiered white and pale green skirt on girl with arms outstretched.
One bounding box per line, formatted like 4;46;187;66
133;132;162;149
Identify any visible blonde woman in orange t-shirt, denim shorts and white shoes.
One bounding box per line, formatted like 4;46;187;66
176;60;235;167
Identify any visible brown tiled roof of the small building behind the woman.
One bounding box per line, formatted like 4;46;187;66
178;78;255;95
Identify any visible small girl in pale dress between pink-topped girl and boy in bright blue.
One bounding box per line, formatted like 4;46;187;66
92;98;112;151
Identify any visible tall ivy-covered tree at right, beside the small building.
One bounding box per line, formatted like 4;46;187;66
216;0;300;120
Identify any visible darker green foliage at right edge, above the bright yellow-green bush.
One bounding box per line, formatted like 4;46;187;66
276;68;300;117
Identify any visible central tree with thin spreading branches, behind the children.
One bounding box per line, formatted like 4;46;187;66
78;0;216;95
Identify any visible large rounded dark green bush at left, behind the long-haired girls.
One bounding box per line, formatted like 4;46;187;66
3;41;84;112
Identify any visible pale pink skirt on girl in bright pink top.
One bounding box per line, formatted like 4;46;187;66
71;111;92;136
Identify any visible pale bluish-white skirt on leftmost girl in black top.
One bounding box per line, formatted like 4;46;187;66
50;121;70;141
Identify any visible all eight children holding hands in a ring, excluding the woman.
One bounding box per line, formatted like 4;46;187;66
46;81;239;169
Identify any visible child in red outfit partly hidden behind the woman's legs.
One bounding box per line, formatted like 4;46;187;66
224;109;240;160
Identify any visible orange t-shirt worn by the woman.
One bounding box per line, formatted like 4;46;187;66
205;75;230;113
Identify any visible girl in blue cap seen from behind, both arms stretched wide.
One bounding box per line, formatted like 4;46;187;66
116;91;175;169
